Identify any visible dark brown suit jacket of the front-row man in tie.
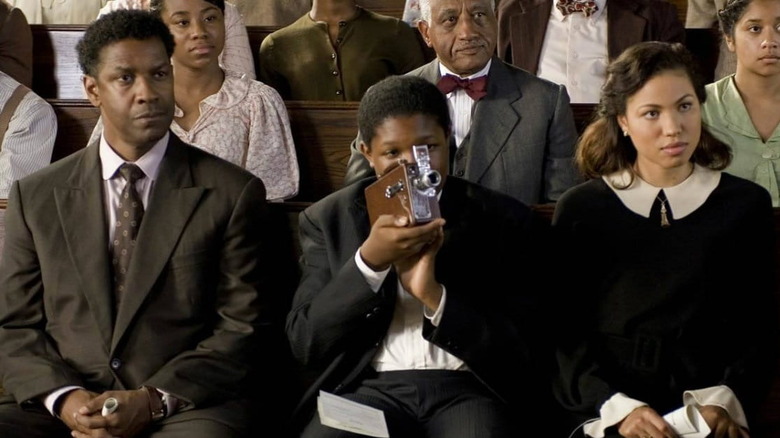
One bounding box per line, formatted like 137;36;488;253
0;134;281;424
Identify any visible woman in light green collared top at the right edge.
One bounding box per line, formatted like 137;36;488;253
702;0;780;207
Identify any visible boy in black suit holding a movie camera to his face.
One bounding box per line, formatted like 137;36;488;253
287;76;551;438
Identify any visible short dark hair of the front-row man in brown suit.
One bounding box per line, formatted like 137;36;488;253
76;9;175;77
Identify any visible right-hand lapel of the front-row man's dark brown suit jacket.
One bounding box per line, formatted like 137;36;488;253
111;135;204;349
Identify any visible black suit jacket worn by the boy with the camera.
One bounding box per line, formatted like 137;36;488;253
287;177;550;432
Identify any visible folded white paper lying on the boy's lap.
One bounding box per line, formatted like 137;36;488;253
317;391;390;438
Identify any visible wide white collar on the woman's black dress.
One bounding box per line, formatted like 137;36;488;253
602;164;721;219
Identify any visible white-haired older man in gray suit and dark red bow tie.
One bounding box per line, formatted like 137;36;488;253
346;0;578;205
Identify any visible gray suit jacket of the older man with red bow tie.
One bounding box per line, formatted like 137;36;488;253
346;58;580;205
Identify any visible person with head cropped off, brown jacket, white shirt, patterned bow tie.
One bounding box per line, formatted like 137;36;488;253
497;0;685;103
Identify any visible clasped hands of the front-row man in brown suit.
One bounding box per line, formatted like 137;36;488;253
73;389;152;438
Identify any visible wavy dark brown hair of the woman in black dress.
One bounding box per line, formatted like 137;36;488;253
575;41;732;185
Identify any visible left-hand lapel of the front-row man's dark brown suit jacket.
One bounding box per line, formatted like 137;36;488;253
54;143;114;347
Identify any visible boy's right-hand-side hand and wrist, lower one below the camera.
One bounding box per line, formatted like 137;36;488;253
394;219;444;312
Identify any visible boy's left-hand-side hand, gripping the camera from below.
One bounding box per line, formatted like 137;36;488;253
360;215;444;271
